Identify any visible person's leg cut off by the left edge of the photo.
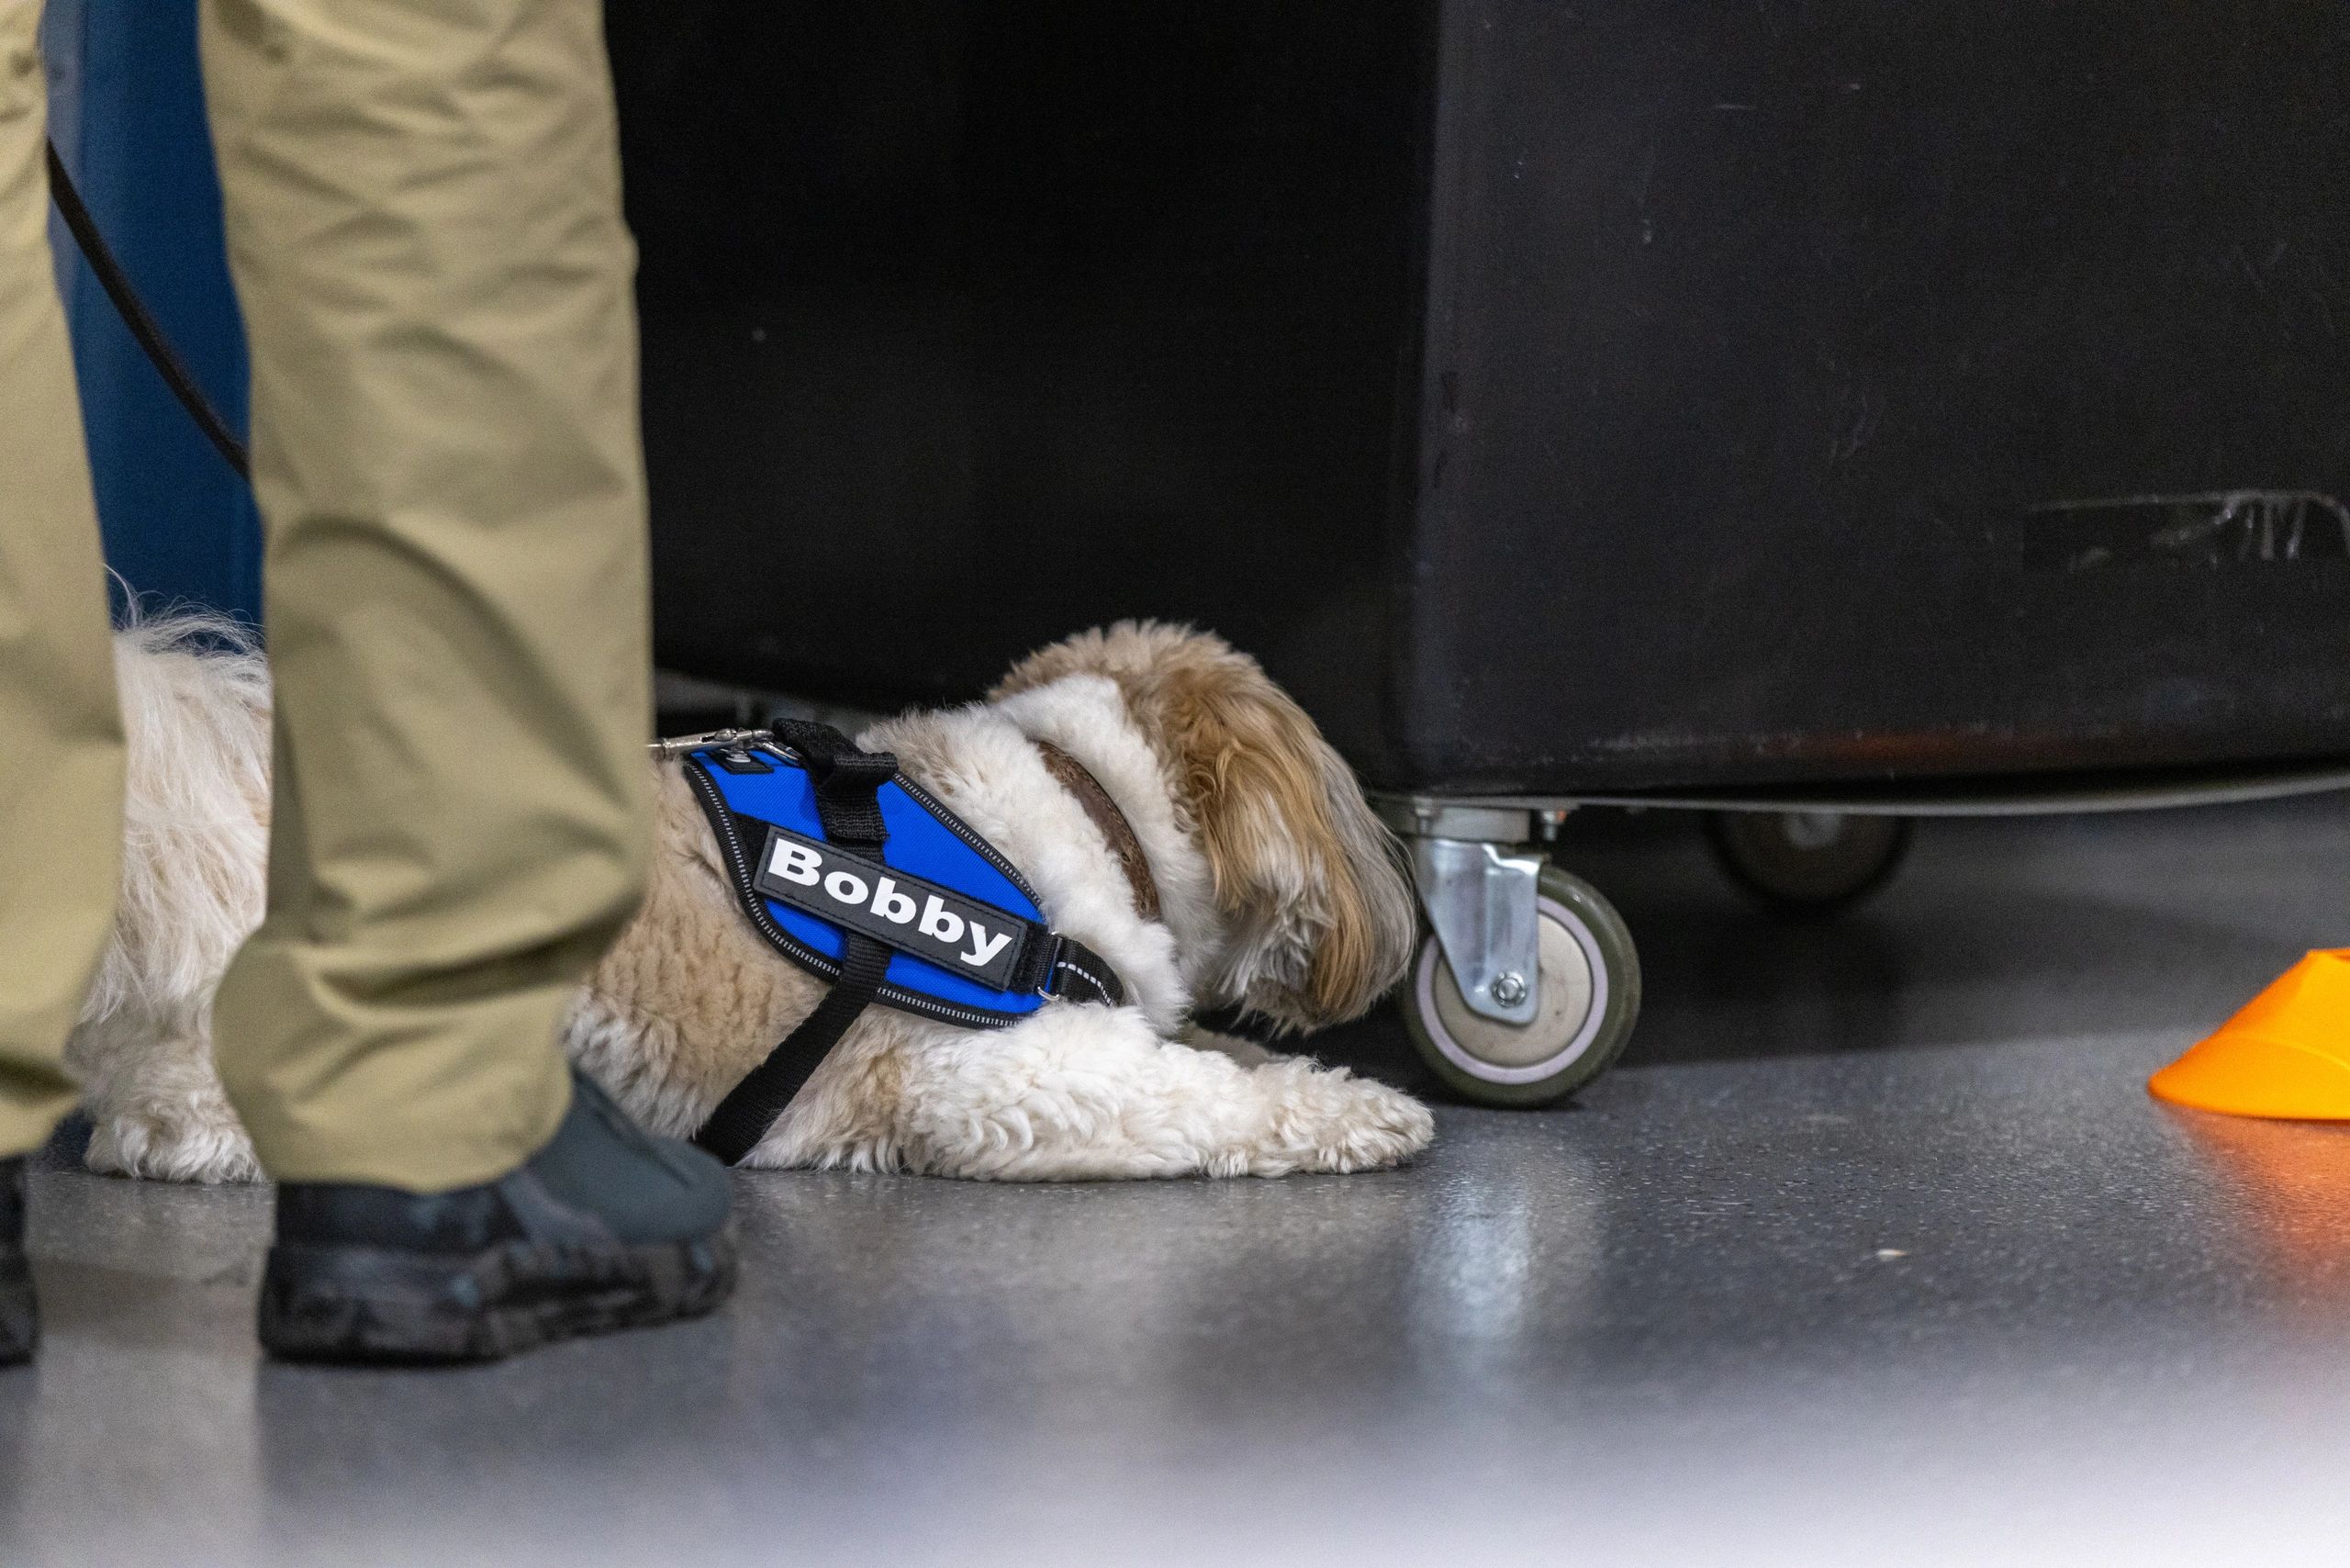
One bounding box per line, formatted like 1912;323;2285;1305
0;0;122;1361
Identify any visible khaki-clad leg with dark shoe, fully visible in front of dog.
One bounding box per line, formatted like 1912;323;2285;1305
205;0;733;1361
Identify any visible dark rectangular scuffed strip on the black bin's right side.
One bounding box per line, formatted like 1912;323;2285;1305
2026;489;2350;574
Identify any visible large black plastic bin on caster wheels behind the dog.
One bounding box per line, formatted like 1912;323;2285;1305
611;0;2350;1100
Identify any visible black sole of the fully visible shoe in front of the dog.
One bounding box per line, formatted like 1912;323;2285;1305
261;1234;735;1363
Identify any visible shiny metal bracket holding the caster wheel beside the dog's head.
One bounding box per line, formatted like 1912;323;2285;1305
1382;801;1541;1025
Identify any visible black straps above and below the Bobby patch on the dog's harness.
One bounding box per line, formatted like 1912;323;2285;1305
693;720;898;1166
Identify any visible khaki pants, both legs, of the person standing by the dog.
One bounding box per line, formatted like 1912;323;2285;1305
0;0;651;1190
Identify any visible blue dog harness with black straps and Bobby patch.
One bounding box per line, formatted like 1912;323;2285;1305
665;720;1125;1164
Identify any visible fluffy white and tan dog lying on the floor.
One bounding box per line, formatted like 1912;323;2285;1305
68;618;1434;1182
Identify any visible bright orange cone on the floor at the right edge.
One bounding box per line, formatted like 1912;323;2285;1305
2145;947;2350;1121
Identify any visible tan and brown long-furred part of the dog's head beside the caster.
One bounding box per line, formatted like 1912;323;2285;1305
999;621;1417;1030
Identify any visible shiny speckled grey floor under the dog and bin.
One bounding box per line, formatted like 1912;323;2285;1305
0;801;2350;1568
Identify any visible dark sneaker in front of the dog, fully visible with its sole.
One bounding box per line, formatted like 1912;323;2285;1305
261;1072;735;1361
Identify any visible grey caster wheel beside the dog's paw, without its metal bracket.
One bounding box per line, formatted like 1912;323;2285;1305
1403;865;1640;1105
